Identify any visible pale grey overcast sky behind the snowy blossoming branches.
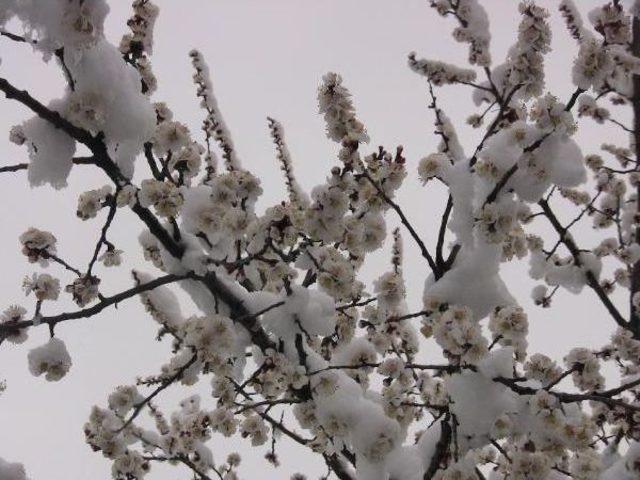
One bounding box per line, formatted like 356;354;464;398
0;0;624;480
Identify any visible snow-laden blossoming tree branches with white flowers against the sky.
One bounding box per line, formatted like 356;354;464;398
0;0;640;480
